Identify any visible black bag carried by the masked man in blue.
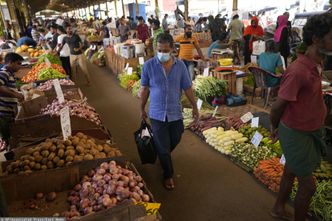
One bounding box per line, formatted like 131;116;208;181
134;120;157;164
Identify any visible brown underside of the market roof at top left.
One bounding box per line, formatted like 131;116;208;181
27;0;112;13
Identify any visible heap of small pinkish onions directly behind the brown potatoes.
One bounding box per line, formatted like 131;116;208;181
41;99;101;125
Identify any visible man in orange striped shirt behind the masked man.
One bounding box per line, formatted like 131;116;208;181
175;25;204;80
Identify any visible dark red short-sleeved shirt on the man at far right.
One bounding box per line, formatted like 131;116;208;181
278;55;326;131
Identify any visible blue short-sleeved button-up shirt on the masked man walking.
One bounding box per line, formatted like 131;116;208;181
141;57;192;122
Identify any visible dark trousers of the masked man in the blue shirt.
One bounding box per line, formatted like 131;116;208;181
151;119;184;179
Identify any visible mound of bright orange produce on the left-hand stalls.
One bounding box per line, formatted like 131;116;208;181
22;63;66;83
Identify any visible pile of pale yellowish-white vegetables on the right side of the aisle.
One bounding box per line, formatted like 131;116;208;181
203;127;248;155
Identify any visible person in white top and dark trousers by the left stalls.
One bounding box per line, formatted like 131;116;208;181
56;26;72;78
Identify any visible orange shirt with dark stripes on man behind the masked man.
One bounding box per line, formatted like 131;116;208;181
175;35;198;61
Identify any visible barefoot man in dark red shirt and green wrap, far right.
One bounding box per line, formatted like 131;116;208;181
270;13;332;221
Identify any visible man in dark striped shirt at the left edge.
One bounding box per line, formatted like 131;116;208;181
0;53;24;143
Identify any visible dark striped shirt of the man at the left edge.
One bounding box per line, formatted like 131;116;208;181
0;66;17;118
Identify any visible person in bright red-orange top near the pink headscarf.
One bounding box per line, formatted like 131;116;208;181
244;16;264;64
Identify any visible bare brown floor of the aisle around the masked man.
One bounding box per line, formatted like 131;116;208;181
79;66;288;221
